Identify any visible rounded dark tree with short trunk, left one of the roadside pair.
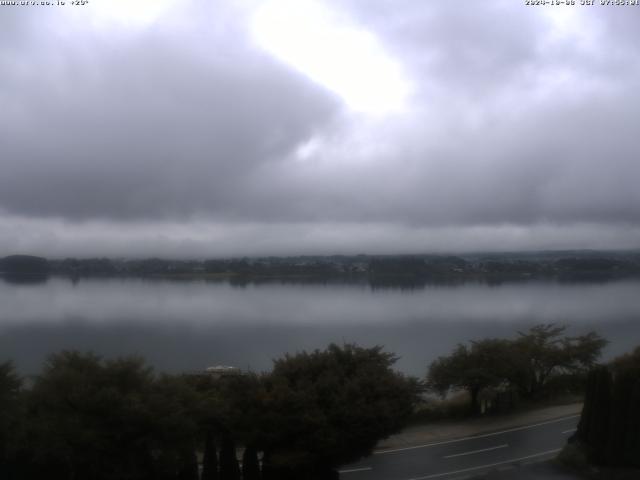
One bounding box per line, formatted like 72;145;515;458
427;339;513;413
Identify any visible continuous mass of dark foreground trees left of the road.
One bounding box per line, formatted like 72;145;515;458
0;345;418;480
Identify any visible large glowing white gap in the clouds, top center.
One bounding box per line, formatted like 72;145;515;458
251;0;409;113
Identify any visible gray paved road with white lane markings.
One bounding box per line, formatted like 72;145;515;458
340;415;580;480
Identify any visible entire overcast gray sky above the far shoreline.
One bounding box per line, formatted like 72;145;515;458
0;0;640;257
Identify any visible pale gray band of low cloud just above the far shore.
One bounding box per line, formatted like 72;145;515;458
0;216;640;258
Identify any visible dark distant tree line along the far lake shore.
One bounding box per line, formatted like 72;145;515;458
0;252;640;286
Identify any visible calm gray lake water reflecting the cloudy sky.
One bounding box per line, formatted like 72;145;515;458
0;278;640;375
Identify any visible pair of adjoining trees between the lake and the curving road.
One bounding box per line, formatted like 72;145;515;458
427;324;607;413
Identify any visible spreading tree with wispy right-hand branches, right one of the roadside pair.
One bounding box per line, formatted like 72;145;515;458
511;323;608;397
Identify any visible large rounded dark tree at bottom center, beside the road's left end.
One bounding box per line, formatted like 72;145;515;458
260;344;417;479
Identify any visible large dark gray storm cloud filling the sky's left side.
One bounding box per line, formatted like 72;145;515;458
0;3;336;219
